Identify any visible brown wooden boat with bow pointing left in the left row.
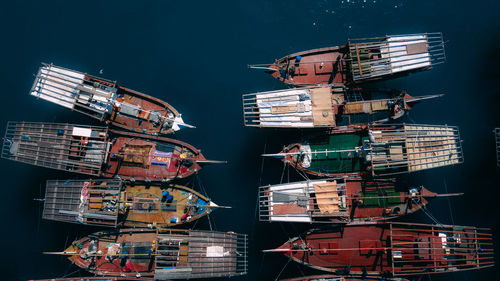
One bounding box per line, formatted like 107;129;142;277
46;228;248;280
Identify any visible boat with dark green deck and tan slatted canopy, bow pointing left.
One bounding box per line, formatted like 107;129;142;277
263;124;463;177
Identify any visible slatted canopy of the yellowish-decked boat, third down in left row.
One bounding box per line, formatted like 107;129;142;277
42;179;122;226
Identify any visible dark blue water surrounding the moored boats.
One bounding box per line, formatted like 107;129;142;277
0;0;500;280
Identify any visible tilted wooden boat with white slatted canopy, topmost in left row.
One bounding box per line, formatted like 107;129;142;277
30;63;193;135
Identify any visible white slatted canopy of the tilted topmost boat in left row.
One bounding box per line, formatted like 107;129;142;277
30;63;116;118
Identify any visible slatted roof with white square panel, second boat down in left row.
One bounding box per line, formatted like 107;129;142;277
2;121;109;175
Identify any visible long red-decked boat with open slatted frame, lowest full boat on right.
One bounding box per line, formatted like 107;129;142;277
266;222;494;277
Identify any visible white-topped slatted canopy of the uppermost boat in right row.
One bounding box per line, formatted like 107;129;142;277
348;32;445;82
